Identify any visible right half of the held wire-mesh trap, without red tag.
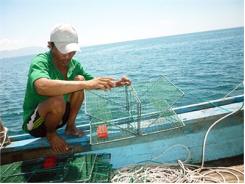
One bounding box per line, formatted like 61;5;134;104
136;75;184;135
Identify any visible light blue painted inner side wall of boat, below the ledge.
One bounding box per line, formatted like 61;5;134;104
88;117;244;168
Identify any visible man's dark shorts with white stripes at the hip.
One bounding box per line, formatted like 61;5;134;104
29;102;70;137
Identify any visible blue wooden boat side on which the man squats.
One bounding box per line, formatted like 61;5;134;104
1;95;244;168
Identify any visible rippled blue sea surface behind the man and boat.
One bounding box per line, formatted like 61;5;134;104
0;27;244;135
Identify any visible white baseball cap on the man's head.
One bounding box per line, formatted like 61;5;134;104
50;24;80;54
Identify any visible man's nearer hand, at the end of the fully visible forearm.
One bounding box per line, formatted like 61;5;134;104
86;77;115;90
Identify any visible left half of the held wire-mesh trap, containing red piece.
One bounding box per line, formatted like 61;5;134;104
85;86;141;144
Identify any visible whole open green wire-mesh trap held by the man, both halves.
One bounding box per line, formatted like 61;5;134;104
85;76;184;144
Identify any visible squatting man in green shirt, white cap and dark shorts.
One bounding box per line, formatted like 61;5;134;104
23;24;131;152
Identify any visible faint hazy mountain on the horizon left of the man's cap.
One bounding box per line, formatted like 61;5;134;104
0;47;48;58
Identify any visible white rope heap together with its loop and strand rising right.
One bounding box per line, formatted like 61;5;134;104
111;104;244;183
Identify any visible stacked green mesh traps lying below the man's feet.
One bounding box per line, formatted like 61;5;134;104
0;154;112;183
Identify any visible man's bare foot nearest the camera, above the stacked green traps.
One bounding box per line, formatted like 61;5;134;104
47;133;69;152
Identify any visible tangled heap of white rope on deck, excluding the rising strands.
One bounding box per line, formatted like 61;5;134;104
111;162;243;183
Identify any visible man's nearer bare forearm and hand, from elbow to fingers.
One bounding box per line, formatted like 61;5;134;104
34;77;115;96
